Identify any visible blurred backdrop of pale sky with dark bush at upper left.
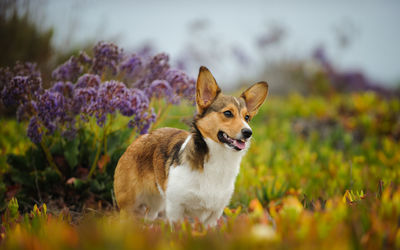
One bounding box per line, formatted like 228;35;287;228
0;0;400;94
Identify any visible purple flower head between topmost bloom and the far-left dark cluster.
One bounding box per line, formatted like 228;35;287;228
51;56;83;81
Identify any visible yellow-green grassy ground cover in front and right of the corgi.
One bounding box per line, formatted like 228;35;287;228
0;92;400;249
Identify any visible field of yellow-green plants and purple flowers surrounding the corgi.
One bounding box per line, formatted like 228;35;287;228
0;42;400;249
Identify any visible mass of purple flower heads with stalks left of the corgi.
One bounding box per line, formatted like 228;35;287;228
0;42;195;177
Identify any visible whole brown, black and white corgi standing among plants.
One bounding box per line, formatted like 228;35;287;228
114;66;268;227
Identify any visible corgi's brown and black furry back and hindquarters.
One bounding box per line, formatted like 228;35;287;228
114;128;189;219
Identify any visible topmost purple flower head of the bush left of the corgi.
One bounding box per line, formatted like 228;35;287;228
92;42;123;76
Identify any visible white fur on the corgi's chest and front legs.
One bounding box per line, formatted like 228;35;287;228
165;137;245;226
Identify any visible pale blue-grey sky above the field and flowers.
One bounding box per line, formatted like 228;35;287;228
35;0;400;88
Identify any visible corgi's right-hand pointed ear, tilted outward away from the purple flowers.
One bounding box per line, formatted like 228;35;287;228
240;82;268;117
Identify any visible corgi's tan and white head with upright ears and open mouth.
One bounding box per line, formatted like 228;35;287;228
196;66;268;151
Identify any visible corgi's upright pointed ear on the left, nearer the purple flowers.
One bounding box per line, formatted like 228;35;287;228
196;66;221;114
